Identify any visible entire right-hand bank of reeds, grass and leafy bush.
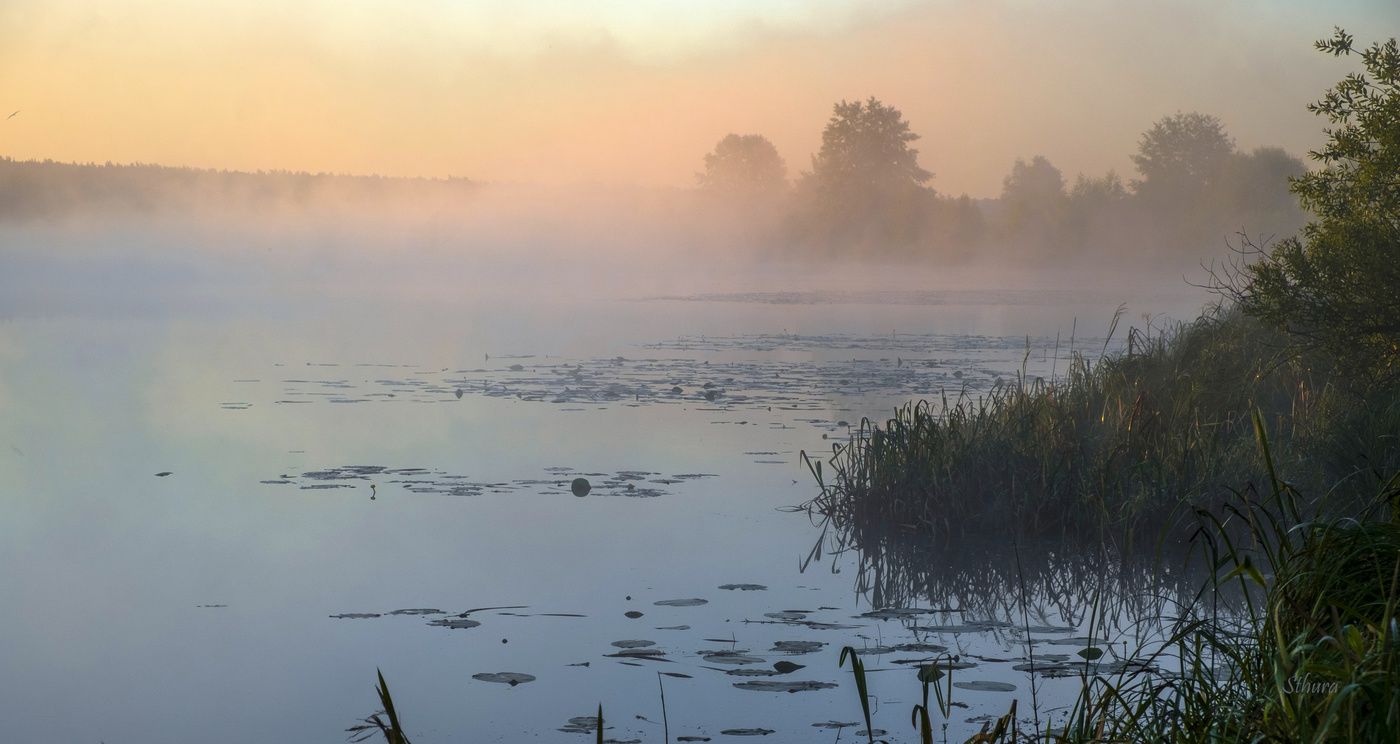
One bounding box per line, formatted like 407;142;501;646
808;29;1400;743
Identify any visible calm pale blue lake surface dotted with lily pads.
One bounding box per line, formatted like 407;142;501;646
0;281;1200;744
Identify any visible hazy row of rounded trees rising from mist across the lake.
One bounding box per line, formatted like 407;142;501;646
699;98;1306;261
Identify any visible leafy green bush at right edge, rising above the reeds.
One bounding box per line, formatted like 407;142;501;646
1243;28;1400;381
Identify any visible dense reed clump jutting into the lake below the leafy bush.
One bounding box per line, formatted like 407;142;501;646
811;301;1400;545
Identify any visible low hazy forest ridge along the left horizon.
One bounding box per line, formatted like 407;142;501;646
0;157;477;221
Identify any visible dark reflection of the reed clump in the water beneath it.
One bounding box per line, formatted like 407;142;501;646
804;517;1236;671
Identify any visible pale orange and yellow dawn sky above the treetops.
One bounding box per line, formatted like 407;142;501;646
0;0;1400;198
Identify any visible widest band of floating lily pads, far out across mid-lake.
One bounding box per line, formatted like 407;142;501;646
240;333;1080;417
